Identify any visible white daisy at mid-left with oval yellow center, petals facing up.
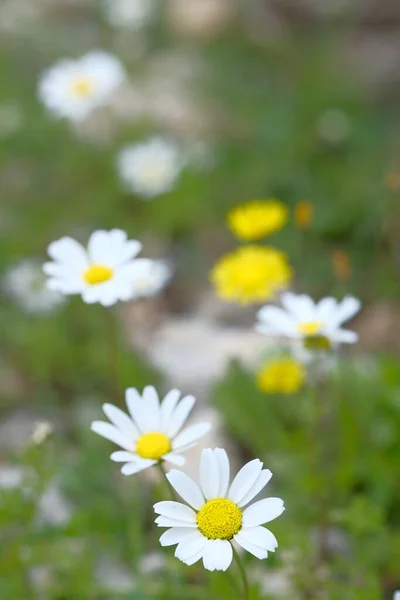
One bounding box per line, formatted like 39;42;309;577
43;229;142;306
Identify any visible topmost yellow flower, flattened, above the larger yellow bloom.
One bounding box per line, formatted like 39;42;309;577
227;198;288;242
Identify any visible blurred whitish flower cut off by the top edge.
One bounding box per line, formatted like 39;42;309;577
104;0;156;30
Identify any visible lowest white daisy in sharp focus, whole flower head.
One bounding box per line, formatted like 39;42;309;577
154;448;285;571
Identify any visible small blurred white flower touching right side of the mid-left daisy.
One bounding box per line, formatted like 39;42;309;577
132;258;172;298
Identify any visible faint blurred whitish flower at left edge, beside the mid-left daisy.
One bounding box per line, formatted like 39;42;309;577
3;259;65;314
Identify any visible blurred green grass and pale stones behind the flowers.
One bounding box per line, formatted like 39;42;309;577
0;0;400;600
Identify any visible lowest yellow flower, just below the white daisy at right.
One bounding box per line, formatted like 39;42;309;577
257;357;306;394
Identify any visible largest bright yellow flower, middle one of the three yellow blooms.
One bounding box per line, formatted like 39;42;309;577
211;245;292;304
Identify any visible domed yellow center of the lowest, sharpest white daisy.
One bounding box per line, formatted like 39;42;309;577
197;498;242;540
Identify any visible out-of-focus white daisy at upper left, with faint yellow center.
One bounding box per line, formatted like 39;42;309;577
38;51;125;121
